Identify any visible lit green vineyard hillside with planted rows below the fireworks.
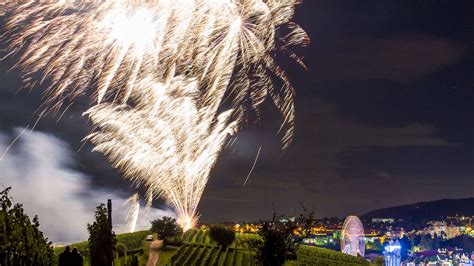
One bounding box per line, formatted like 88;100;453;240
54;229;370;266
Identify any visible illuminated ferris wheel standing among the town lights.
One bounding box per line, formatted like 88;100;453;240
341;215;365;257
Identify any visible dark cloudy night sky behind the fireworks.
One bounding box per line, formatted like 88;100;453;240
0;0;474;222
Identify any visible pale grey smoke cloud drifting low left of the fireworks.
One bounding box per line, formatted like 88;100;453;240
0;130;175;242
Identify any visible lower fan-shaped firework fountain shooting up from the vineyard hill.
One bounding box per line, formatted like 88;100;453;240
87;77;238;229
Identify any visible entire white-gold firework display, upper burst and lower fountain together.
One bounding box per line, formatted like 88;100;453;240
3;0;309;229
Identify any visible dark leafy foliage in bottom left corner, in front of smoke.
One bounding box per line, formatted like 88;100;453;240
0;187;53;265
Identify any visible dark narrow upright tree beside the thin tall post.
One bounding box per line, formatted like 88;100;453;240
87;204;117;266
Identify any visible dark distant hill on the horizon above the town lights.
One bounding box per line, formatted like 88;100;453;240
361;198;474;222
